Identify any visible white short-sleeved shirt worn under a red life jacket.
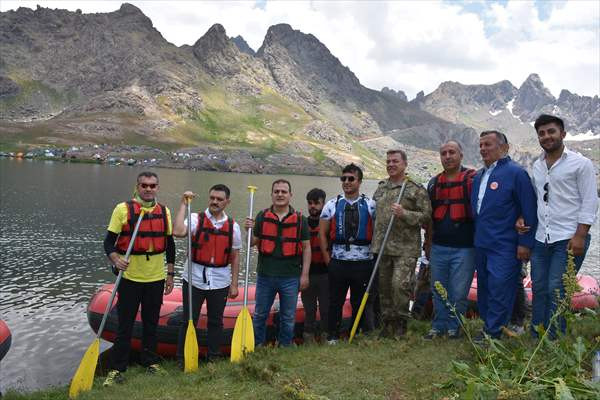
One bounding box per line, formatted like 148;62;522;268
183;208;242;290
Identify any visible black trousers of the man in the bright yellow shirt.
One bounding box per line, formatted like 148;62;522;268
111;278;165;372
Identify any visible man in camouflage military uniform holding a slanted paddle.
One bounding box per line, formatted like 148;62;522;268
371;150;431;337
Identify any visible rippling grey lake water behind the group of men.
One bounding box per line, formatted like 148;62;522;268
0;159;600;391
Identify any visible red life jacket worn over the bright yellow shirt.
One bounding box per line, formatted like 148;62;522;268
115;200;169;255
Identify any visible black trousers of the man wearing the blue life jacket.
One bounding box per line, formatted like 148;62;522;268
327;259;374;340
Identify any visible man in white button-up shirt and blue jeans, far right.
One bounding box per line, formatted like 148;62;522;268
517;114;598;337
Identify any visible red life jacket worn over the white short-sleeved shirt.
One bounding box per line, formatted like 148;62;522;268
192;212;233;268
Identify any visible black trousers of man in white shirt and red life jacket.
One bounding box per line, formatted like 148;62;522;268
177;280;229;358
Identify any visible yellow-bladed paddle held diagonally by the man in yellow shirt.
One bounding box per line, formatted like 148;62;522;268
69;209;144;399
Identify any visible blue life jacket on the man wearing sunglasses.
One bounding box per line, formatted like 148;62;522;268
329;194;373;251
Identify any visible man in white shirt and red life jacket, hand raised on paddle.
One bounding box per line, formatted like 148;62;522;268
173;184;242;360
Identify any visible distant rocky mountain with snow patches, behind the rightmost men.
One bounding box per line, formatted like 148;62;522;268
411;74;600;146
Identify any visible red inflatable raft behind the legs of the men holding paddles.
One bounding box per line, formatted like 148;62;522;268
87;284;352;356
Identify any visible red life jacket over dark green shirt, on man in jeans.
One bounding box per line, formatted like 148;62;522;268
258;207;302;257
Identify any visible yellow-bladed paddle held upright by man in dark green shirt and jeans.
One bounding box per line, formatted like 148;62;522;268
231;186;256;362
